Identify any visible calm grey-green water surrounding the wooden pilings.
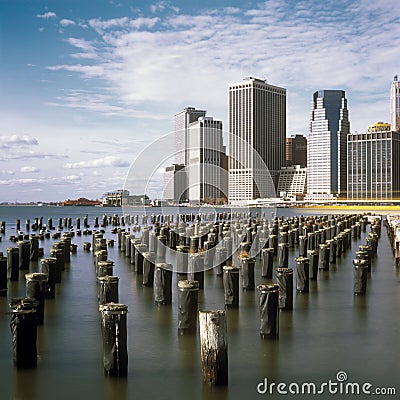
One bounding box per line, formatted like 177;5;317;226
0;207;400;400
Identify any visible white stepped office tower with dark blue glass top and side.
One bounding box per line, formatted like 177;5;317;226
307;90;350;200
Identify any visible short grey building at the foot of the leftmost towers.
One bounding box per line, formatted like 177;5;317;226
162;164;188;204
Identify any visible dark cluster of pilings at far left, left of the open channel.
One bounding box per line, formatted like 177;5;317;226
4;227;76;369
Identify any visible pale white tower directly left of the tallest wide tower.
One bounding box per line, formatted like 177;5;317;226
187;117;228;204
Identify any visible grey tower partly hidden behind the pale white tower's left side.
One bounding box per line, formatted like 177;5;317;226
174;107;206;165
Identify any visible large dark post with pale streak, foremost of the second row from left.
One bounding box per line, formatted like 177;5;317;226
99;303;128;376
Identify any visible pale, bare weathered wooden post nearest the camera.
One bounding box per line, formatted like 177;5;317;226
199;310;228;386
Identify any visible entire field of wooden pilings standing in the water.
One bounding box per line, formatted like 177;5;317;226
0;213;380;385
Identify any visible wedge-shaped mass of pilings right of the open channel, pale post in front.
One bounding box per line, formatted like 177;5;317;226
109;209;376;384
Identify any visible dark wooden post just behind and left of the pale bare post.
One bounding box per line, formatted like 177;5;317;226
178;280;199;335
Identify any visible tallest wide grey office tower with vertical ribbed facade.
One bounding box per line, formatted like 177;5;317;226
228;77;286;202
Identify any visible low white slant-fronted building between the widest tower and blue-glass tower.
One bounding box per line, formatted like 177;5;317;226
277;165;307;198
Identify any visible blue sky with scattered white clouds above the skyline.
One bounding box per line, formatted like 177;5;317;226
0;0;400;202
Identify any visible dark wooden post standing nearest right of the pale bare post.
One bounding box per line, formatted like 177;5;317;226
257;284;279;339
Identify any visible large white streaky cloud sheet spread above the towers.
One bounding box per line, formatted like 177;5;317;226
43;0;400;131
